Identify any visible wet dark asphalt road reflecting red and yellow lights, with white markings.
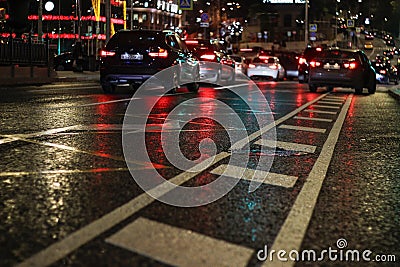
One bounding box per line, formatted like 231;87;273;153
0;81;400;266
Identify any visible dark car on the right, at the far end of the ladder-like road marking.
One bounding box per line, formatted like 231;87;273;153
308;48;376;94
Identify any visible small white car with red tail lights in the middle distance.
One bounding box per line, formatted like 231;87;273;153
247;55;285;81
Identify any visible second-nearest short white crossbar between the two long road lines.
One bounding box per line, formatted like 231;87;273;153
211;164;297;188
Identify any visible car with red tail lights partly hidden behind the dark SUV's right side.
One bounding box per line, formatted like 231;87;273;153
185;39;235;84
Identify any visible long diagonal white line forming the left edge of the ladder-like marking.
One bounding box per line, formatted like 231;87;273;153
17;94;327;267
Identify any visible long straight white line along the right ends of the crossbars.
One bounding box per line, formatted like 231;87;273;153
263;95;352;266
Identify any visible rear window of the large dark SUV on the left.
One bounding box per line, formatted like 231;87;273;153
107;31;165;49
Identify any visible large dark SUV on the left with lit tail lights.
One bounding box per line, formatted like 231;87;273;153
100;30;199;92
